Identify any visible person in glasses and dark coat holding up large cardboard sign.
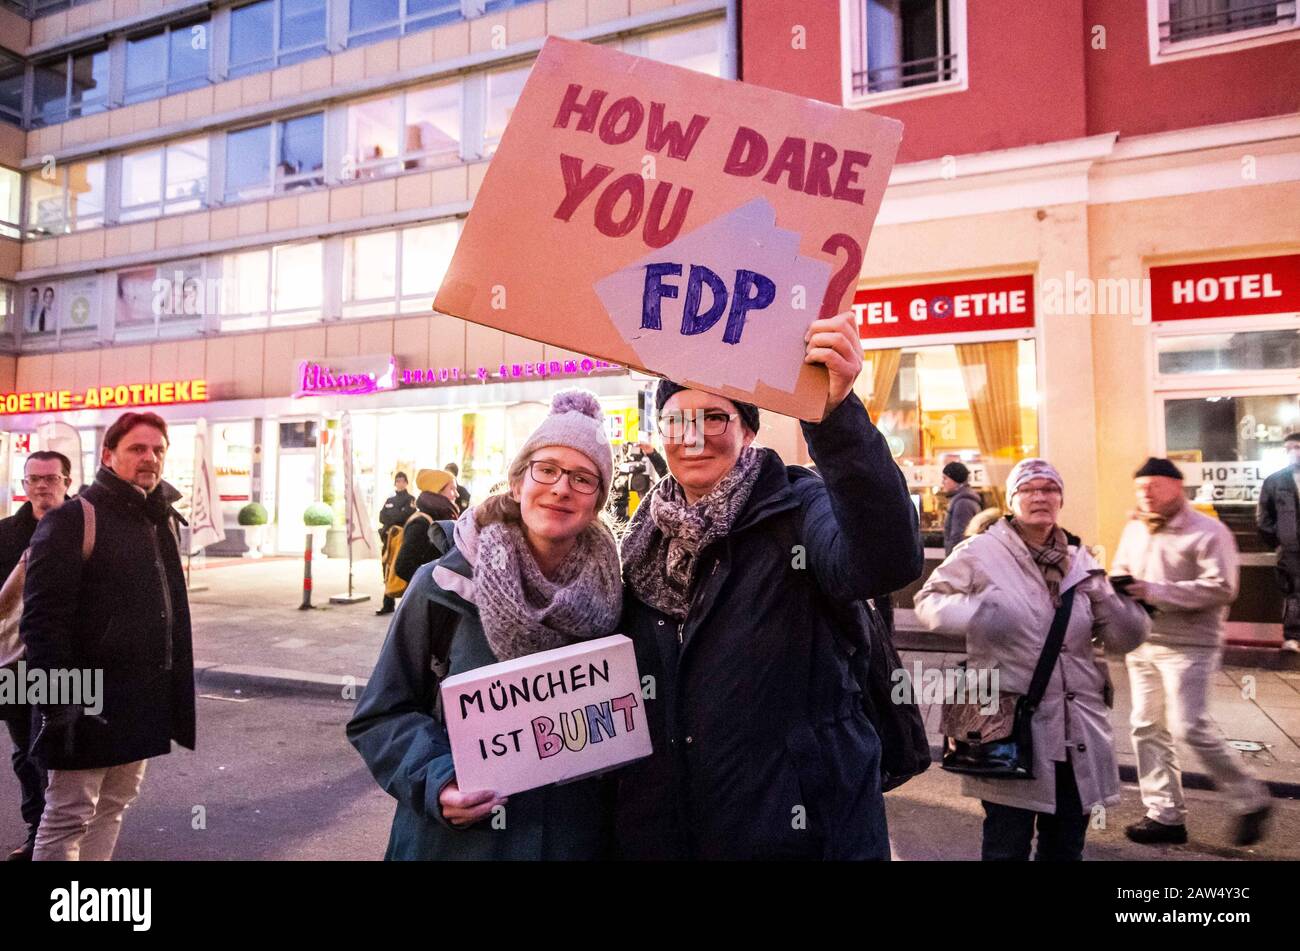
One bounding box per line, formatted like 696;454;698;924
614;313;923;859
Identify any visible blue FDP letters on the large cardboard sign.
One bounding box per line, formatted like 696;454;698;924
641;261;776;344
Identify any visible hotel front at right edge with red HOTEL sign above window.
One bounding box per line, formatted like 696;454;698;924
1149;253;1300;633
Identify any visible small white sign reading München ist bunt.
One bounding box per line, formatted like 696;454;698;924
442;634;650;795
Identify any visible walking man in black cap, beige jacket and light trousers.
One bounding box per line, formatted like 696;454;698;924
1112;457;1271;846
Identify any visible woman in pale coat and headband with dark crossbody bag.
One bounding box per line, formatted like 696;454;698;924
915;459;1151;861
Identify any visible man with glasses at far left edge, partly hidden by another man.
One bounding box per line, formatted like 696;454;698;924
0;451;73;861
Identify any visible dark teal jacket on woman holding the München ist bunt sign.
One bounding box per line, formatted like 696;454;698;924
347;548;607;860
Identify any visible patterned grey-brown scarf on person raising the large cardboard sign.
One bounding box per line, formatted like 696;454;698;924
621;446;767;620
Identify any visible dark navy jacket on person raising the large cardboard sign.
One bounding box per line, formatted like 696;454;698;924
615;395;923;859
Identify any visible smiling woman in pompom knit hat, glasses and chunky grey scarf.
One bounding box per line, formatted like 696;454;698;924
347;390;623;860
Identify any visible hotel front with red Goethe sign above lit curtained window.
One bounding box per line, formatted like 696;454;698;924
853;267;1040;550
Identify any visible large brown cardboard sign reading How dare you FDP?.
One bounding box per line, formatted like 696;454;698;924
434;36;902;420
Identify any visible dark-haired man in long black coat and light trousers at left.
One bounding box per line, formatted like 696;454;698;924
21;413;195;861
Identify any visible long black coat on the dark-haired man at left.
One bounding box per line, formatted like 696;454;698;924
20;468;195;769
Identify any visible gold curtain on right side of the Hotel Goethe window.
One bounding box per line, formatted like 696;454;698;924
957;340;1023;504
